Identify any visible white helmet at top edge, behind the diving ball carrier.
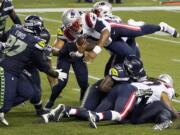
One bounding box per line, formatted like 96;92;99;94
92;1;112;17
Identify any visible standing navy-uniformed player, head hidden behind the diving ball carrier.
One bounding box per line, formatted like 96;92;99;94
45;21;88;110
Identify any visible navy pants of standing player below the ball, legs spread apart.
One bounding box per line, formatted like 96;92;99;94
50;58;88;102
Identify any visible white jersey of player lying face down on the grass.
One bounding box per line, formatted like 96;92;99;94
131;81;175;104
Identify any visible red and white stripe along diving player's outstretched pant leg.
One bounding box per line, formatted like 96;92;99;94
111;23;141;31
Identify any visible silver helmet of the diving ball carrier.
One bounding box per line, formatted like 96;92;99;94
62;9;81;32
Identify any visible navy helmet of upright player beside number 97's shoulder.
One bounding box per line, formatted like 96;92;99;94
24;15;44;35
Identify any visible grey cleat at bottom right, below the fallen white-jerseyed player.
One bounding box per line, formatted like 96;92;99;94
153;120;172;131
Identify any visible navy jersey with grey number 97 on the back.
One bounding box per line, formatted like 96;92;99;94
0;25;50;76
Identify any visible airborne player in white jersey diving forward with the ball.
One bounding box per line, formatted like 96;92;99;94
62;9;179;59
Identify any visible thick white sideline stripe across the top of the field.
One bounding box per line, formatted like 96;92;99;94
15;6;180;13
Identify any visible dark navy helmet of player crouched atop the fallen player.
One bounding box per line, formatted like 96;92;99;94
124;56;147;81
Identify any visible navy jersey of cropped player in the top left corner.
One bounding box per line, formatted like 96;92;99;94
0;0;14;38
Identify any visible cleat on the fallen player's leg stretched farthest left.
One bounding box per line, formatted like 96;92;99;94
51;104;65;121
